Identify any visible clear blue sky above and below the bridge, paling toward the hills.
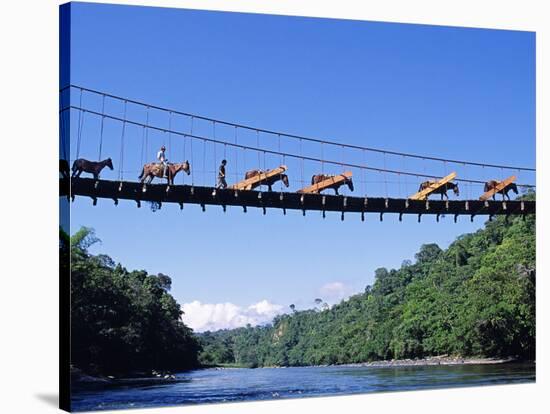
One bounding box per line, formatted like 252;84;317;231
64;3;535;330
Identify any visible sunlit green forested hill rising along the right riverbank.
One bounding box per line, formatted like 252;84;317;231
200;202;535;367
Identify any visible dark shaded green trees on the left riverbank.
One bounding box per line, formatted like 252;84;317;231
67;228;199;373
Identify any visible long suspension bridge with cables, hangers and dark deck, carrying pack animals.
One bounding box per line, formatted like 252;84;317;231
60;85;536;222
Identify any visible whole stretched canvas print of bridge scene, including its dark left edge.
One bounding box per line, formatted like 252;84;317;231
59;3;536;411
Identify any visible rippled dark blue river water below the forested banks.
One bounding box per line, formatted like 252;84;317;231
72;363;535;411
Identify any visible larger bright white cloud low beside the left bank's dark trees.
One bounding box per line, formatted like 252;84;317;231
182;299;284;332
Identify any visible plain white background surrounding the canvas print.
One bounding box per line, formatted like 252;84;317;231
0;0;550;414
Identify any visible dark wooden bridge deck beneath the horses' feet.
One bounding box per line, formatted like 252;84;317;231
59;178;536;220
